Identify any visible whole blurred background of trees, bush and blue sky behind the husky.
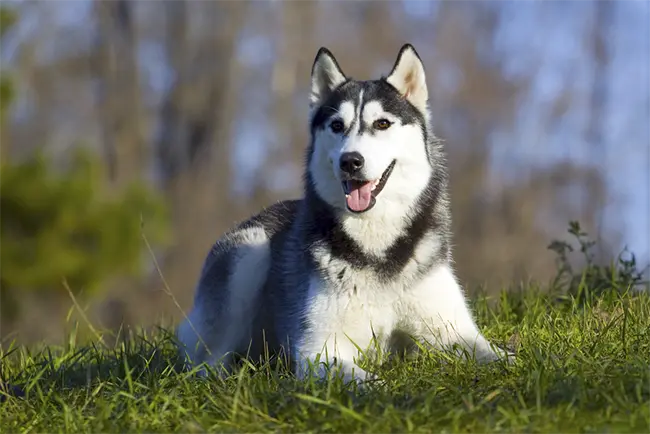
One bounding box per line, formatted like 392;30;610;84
0;0;650;344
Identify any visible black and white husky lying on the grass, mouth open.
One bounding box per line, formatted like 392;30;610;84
177;44;509;381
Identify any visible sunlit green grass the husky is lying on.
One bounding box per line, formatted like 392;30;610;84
0;289;650;433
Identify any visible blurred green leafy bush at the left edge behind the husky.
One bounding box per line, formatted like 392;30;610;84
0;5;166;325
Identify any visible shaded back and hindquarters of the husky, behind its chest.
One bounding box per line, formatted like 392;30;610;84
178;200;301;372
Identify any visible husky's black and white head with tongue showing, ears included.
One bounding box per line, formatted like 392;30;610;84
308;44;432;217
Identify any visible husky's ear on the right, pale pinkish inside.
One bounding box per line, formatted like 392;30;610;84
386;44;429;111
